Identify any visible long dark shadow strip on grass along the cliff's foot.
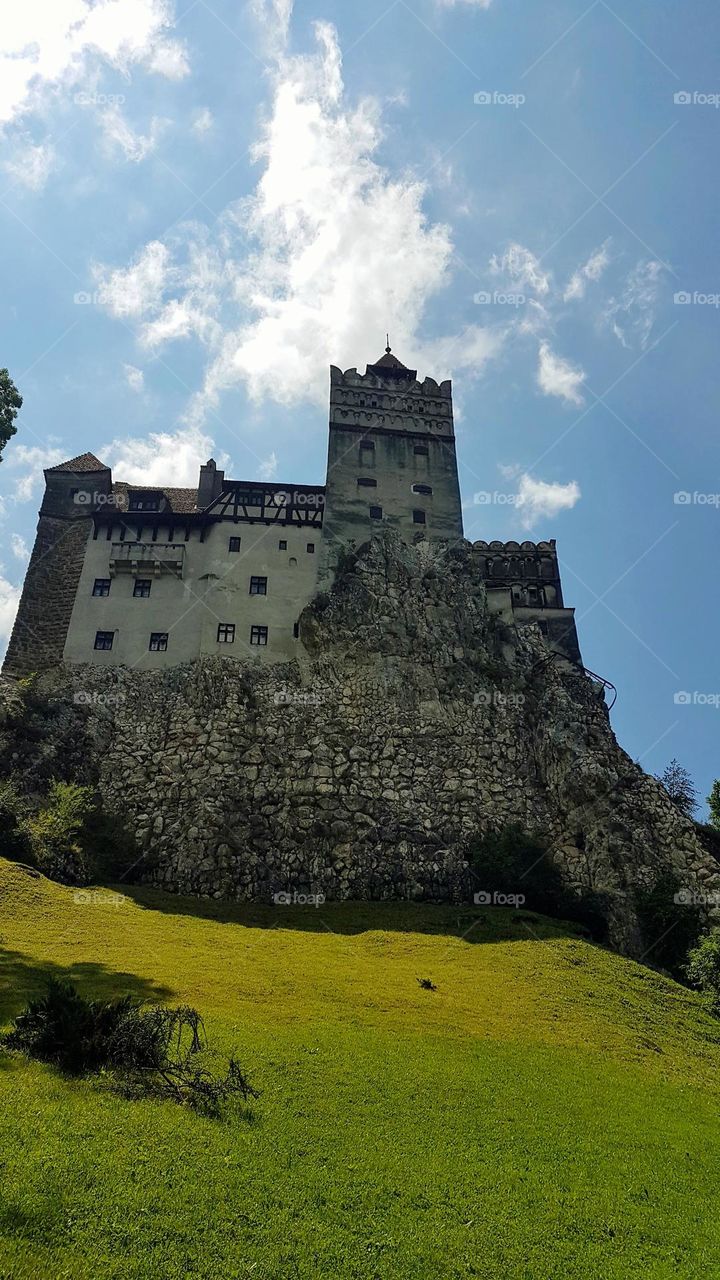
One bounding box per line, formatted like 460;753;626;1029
115;884;589;942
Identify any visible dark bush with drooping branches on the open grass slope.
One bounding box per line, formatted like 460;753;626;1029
0;979;259;1115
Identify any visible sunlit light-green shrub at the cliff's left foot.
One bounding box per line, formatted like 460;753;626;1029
22;782;92;884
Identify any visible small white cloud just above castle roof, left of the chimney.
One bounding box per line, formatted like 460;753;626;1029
101;428;213;489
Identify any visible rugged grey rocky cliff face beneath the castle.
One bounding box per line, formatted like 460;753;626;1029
0;534;720;954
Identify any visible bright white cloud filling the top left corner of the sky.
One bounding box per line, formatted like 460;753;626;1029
0;0;187;124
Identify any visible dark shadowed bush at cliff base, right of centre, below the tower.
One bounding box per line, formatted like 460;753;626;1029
468;826;607;942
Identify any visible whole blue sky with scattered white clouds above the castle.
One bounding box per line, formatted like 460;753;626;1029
0;0;720;795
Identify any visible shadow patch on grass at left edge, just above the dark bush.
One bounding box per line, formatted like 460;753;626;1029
0;947;173;1029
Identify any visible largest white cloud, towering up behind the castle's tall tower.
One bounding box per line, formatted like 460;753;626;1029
96;20;499;425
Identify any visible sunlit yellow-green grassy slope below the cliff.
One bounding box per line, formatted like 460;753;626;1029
0;861;720;1280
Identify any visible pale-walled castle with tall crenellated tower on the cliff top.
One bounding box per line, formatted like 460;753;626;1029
4;347;580;676
